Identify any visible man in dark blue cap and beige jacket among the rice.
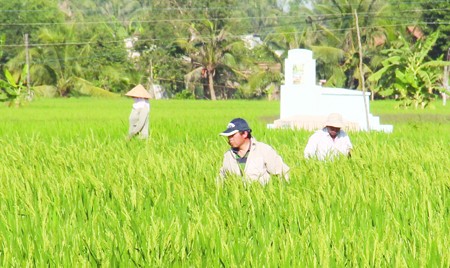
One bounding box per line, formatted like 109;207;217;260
219;118;289;185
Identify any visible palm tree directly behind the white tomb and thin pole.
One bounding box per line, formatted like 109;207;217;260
308;0;389;88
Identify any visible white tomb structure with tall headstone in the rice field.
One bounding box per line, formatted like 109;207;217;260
268;49;393;132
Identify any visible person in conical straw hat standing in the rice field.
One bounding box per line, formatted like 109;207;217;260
125;85;150;140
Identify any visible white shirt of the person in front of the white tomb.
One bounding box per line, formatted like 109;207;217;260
304;127;353;160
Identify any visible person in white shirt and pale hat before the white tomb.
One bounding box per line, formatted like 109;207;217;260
304;113;353;160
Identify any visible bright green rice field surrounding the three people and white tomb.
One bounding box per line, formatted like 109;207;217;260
0;98;450;267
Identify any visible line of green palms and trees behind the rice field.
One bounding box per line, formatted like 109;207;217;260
0;0;450;105
